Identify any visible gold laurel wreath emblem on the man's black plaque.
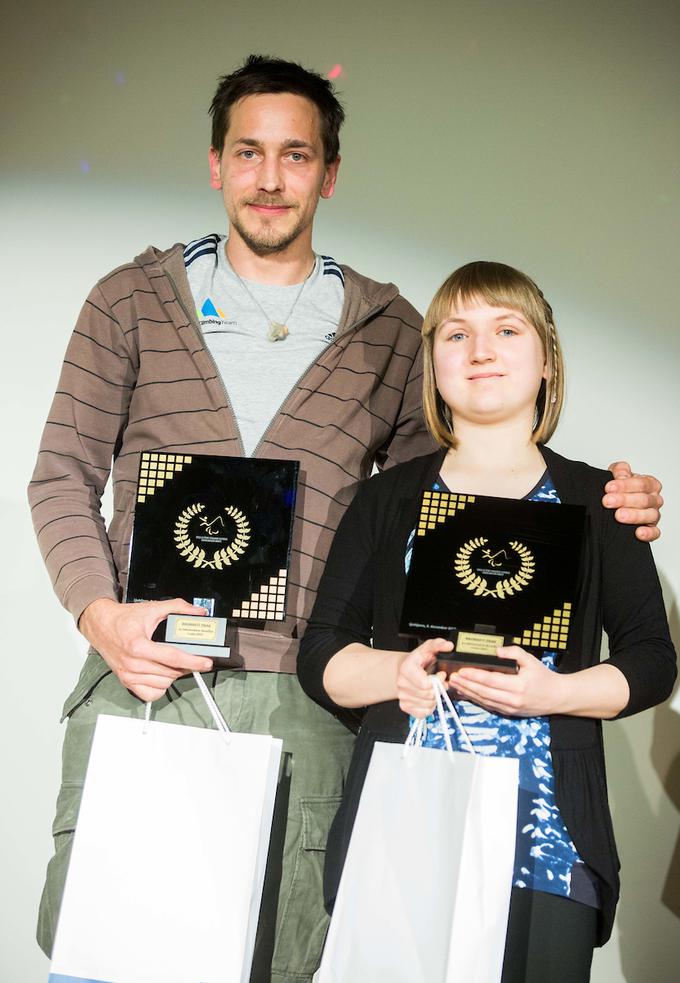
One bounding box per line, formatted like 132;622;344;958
174;502;251;570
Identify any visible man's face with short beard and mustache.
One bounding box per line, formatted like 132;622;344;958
210;92;340;256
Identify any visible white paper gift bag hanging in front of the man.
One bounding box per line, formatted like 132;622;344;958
50;680;281;983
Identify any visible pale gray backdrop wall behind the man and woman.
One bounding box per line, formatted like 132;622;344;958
0;0;680;983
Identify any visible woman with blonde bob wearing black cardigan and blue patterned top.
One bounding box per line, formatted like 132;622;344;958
298;262;675;983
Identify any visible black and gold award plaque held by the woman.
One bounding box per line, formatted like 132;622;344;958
400;491;585;672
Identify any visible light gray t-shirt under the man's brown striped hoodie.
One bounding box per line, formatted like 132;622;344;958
184;235;345;456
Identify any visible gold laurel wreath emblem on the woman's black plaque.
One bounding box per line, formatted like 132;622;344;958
454;536;536;600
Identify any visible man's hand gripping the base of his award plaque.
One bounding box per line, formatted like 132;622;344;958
78;597;212;702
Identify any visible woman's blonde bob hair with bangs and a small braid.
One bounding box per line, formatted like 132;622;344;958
423;260;564;448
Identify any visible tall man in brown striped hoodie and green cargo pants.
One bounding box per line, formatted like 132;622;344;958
29;57;660;983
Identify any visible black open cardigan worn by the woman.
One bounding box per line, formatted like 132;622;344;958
298;447;676;945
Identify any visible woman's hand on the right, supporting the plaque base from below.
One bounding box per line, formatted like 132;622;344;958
446;645;569;717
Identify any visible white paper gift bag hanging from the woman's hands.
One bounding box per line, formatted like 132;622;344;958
315;684;518;983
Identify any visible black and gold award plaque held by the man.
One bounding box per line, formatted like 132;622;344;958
126;451;299;664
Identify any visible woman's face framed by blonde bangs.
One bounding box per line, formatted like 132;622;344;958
432;301;547;433
